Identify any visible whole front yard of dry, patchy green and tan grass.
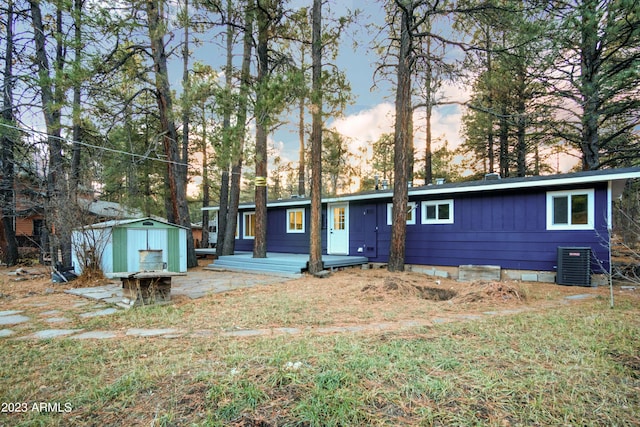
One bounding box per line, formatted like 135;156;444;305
0;262;640;426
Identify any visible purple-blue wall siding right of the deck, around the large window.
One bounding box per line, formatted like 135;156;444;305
370;184;608;271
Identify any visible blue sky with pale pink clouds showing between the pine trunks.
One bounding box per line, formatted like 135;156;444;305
165;0;576;194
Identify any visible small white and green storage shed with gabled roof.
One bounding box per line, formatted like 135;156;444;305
71;218;190;277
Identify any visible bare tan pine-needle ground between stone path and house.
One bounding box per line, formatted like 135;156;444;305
0;260;640;327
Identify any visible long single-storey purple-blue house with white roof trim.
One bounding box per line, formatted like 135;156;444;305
209;168;640;277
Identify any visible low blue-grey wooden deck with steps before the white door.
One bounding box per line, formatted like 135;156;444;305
207;252;369;275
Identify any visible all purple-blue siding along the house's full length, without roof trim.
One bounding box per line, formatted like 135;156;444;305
236;183;608;271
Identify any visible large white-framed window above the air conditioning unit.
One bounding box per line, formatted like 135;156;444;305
547;190;594;230
